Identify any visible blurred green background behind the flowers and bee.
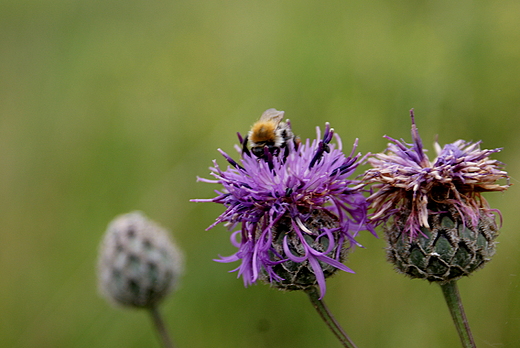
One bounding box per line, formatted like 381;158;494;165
0;0;520;348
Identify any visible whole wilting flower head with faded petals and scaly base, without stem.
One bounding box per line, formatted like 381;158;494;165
365;110;509;283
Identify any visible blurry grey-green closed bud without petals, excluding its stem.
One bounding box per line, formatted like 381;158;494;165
98;212;182;308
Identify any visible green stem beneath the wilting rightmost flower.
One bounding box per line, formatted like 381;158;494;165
441;281;477;348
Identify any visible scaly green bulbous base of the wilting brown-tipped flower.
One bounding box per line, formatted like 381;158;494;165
385;206;498;283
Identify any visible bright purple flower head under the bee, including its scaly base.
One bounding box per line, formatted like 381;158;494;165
192;123;375;297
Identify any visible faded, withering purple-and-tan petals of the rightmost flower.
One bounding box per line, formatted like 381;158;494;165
365;110;509;238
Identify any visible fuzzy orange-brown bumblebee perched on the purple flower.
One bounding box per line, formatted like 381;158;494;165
242;109;298;158
